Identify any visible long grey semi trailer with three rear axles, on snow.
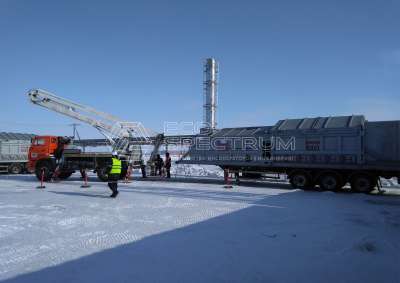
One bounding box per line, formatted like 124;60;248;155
177;115;400;193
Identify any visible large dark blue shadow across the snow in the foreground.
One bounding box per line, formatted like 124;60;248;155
4;191;400;283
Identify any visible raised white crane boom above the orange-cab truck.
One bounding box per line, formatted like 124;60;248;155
28;89;152;155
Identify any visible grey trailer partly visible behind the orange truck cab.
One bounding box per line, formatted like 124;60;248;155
0;132;34;174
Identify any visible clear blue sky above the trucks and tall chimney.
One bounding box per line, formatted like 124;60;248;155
0;0;400;137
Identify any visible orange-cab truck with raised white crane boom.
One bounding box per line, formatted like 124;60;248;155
28;89;150;181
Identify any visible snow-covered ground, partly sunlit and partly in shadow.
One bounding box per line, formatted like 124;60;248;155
0;175;400;283
